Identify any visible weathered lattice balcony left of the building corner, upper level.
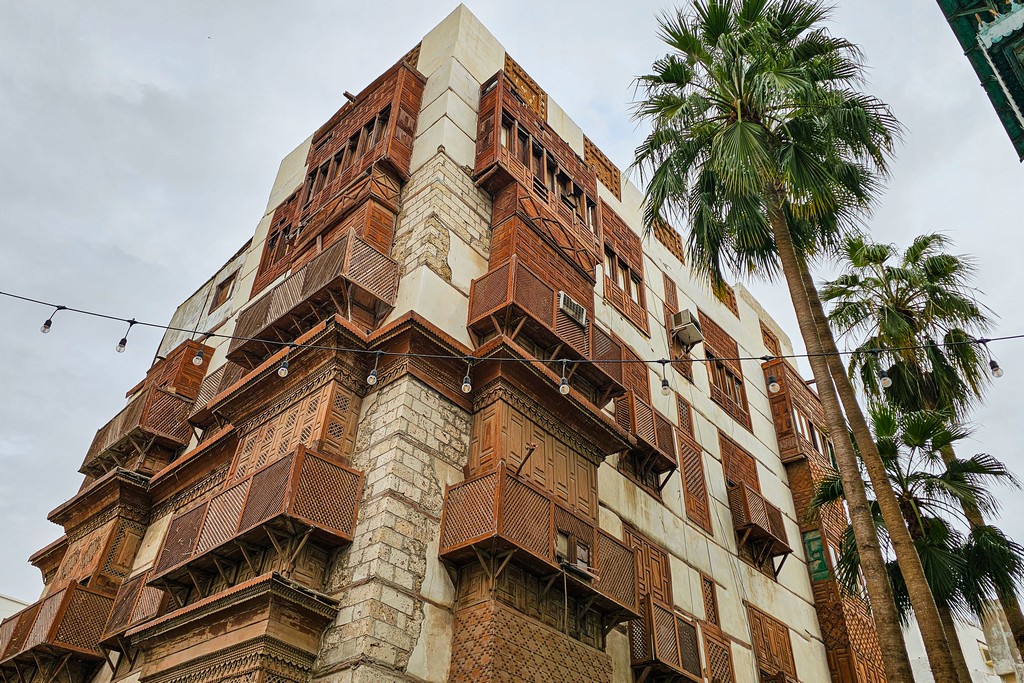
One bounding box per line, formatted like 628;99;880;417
227;230;398;366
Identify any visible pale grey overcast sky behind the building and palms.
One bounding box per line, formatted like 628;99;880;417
0;0;1024;601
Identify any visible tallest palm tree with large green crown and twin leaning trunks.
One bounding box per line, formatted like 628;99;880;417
636;0;955;683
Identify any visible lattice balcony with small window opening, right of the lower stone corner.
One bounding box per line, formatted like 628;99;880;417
439;465;638;618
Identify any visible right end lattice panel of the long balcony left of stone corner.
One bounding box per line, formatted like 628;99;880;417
293;455;361;539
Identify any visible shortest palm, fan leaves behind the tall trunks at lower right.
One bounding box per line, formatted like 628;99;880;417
811;403;1024;683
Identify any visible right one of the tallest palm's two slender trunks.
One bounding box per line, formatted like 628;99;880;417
798;253;956;683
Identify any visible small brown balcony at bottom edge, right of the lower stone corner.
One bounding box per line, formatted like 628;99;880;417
630;596;703;681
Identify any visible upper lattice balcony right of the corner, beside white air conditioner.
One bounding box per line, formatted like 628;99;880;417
469;255;623;396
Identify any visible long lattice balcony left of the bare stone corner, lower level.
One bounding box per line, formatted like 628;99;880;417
148;445;362;585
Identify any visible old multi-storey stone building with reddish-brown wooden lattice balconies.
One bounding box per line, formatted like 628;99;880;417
0;7;884;683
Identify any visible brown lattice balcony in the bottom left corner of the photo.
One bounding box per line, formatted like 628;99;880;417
0;584;114;663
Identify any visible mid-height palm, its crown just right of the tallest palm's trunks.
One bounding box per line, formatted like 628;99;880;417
821;233;1024;653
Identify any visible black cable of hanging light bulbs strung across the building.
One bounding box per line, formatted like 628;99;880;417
0;291;1024;374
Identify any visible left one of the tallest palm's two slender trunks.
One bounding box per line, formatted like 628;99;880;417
768;197;917;683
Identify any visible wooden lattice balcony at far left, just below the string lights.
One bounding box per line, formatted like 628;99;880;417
81;387;193;474
